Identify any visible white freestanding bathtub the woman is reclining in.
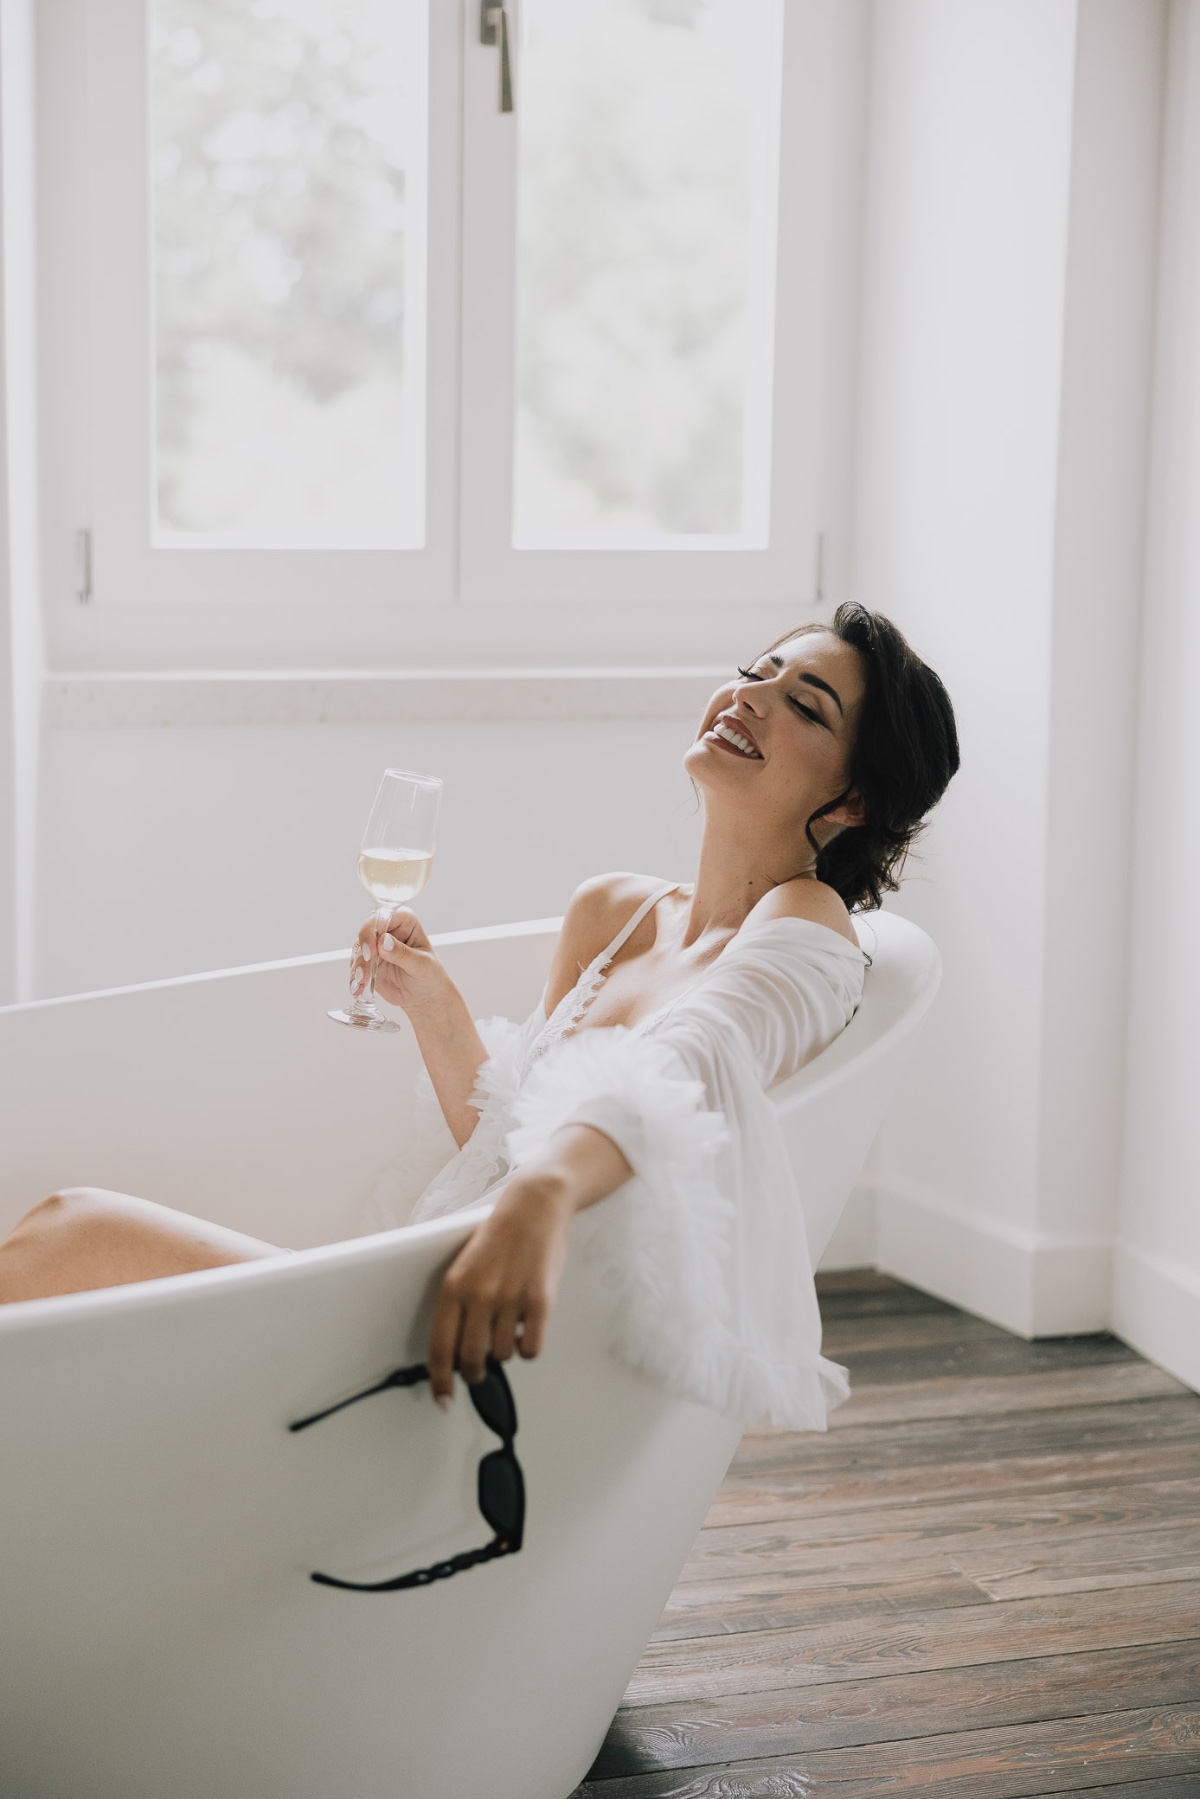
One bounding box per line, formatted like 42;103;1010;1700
0;914;937;1799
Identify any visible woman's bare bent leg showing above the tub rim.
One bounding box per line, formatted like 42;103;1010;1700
0;1187;281;1304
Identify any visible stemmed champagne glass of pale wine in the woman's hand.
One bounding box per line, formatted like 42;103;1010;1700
329;768;441;1031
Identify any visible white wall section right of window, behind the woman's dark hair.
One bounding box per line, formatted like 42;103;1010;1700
855;0;1162;1333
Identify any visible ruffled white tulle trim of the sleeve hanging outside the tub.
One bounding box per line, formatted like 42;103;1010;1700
507;1029;849;1430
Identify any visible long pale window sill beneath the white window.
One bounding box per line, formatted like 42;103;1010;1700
41;667;729;730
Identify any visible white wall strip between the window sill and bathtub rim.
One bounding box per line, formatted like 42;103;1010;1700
36;720;698;997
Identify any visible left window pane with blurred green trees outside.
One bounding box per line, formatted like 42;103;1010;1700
151;0;428;547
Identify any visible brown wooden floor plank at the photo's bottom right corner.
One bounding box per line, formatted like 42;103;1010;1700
578;1704;1200;1799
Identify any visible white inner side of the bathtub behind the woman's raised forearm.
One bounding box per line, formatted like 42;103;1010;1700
0;919;558;1249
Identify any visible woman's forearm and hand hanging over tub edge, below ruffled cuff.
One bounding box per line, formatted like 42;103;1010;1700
428;1124;633;1405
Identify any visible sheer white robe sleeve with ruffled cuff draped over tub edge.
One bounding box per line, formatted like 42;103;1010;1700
507;919;865;1430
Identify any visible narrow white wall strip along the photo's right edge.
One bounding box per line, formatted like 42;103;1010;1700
1114;0;1200;1387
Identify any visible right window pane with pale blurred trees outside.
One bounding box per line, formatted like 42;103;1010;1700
513;0;781;549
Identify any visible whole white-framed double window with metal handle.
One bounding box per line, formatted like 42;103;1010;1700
40;0;862;666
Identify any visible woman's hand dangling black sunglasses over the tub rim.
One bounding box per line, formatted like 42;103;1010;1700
428;1175;576;1407
